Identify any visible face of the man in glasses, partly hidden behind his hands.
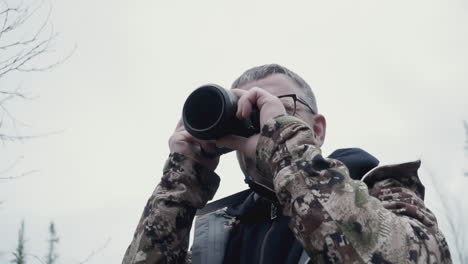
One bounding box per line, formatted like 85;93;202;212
237;74;326;182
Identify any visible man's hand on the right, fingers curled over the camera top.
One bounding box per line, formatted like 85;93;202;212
216;87;286;160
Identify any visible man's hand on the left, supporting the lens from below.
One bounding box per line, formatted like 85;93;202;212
169;119;219;171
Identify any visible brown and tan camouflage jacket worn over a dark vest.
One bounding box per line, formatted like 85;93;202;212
123;116;452;264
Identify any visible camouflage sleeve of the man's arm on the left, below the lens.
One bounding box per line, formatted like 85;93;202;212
122;153;220;264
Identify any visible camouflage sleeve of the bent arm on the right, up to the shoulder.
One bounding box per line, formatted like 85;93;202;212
257;116;451;263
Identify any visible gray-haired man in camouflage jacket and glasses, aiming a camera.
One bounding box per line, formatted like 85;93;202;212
123;64;451;264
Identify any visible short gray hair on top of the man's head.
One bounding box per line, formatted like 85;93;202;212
231;64;318;113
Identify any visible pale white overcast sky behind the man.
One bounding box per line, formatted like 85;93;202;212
0;0;468;263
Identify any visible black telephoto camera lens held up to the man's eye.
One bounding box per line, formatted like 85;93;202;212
182;84;260;140
